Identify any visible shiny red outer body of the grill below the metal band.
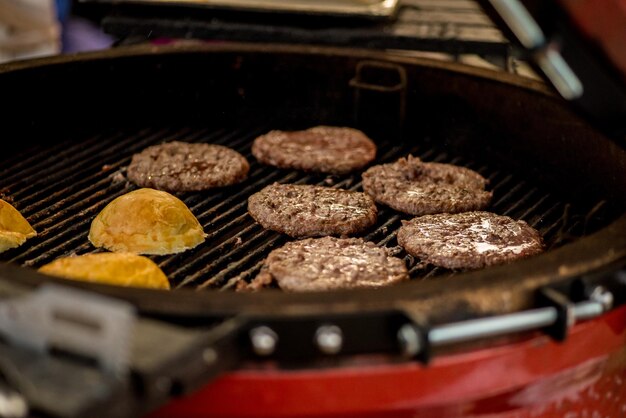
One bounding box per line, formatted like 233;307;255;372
151;307;626;418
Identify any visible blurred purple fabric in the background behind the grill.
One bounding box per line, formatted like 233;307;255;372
63;16;113;53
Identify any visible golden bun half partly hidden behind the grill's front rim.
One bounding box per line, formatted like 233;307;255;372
39;253;170;289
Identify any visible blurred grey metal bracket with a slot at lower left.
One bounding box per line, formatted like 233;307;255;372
0;285;135;377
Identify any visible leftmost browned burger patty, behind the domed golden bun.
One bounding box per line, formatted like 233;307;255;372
128;141;250;192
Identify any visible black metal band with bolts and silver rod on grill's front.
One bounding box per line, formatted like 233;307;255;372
236;273;626;363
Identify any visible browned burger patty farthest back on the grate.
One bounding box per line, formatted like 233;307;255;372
252;126;376;174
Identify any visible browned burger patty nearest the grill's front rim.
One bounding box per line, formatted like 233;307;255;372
251;237;409;292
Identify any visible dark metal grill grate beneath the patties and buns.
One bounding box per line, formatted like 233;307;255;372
0;121;599;289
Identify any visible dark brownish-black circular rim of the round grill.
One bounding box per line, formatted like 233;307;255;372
0;44;626;324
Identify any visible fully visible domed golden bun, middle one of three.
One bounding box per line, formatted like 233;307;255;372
88;188;206;255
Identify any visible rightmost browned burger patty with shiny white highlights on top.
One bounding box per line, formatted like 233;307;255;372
398;212;544;269
